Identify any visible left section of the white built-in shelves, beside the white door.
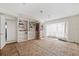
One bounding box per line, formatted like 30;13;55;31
17;19;28;42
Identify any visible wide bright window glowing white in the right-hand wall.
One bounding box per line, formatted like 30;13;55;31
46;22;65;38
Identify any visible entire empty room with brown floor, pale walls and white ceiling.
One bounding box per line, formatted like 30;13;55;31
0;3;79;56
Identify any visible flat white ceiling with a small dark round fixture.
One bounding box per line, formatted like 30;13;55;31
0;3;79;22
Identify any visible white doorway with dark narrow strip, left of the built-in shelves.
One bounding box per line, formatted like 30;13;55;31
5;19;17;43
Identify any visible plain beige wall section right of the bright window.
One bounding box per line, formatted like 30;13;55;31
68;16;79;43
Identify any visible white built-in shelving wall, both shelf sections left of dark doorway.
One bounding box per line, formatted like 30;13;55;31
17;18;37;42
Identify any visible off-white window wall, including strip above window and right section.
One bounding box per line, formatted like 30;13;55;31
45;15;79;43
